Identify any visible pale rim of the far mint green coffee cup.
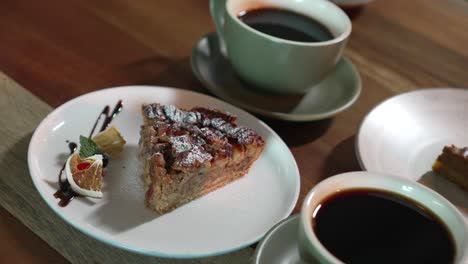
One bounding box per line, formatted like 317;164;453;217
225;0;353;47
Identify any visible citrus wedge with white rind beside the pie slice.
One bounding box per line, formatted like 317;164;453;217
65;153;103;198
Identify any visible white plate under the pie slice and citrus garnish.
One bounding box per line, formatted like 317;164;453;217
28;86;300;258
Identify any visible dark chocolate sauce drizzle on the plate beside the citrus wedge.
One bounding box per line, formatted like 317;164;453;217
54;100;123;207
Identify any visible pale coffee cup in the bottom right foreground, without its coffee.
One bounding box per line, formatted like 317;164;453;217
299;171;468;264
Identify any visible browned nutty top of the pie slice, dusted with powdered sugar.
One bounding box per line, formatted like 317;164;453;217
143;104;263;169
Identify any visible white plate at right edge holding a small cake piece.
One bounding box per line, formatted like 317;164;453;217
356;88;468;220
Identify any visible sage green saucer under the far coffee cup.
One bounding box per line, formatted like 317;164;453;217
191;33;361;121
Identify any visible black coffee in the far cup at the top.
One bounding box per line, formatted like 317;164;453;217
238;8;334;42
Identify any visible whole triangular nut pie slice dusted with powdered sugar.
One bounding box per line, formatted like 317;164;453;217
139;103;265;213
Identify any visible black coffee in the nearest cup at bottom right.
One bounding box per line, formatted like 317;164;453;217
311;189;456;264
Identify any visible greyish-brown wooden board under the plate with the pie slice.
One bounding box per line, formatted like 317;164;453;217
0;72;253;264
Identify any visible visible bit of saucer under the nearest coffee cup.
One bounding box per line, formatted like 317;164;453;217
253;214;305;264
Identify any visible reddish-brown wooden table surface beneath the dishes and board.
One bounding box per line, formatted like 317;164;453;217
0;0;468;263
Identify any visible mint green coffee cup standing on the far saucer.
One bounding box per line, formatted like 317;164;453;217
210;0;351;94
